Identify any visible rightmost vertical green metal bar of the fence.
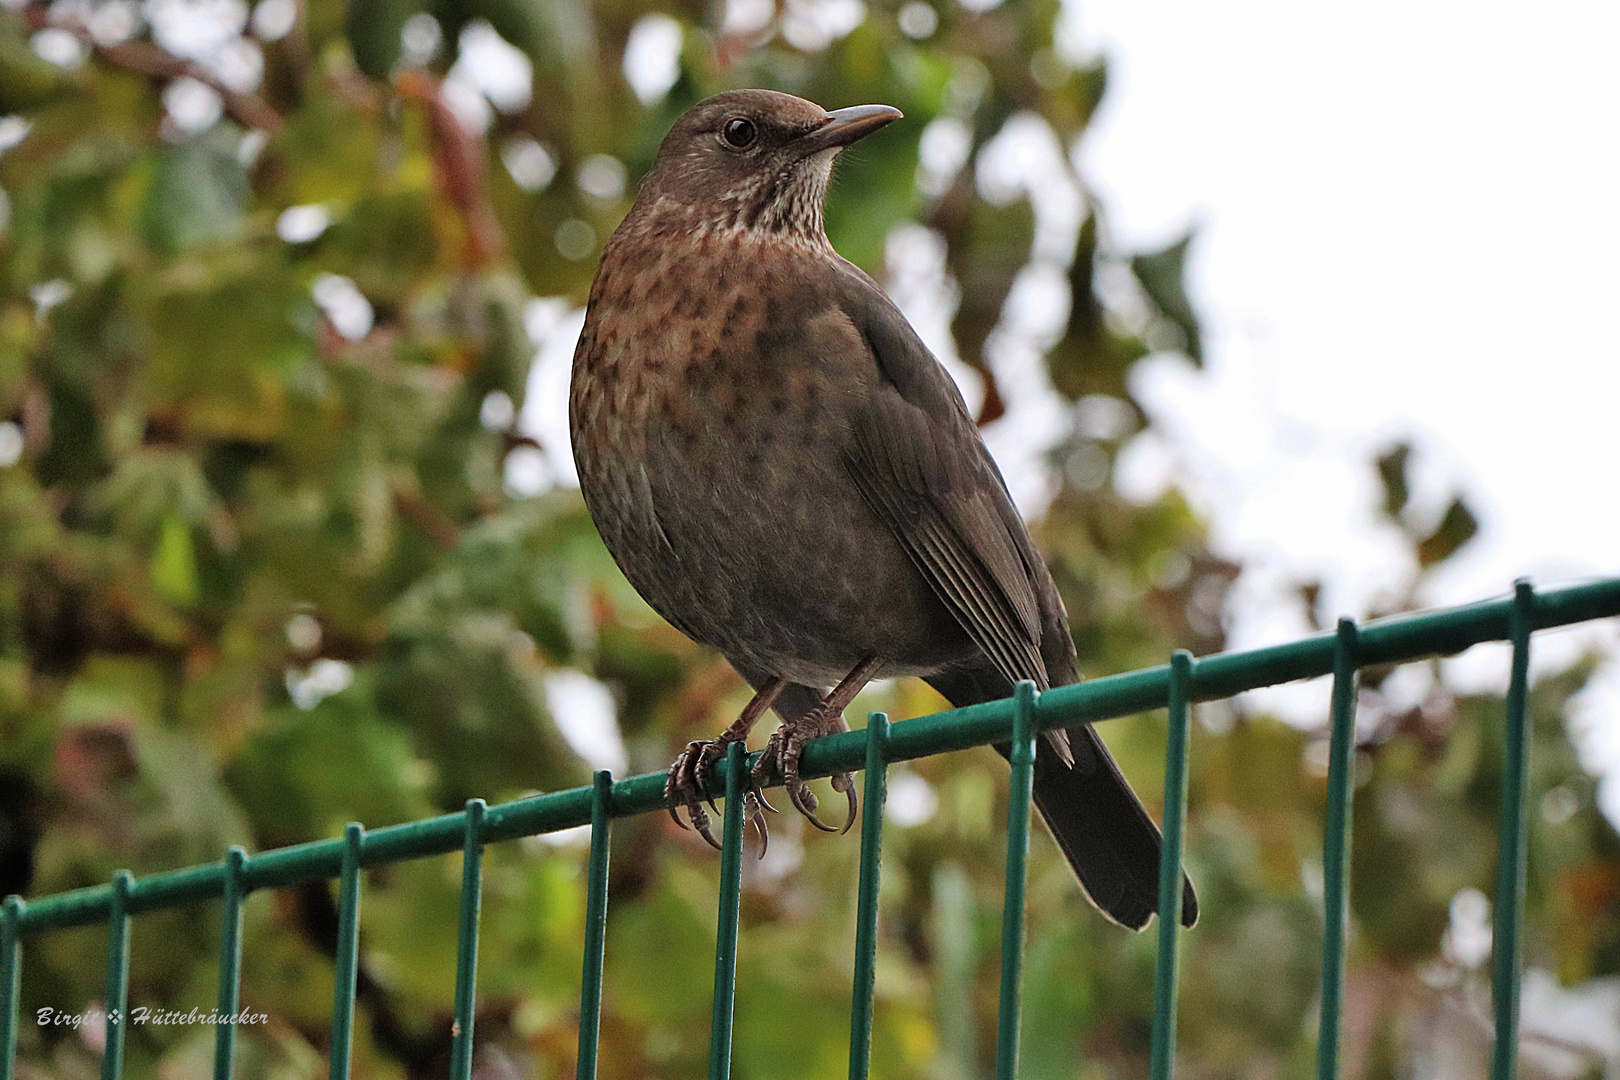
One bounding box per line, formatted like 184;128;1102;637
1490;580;1536;1080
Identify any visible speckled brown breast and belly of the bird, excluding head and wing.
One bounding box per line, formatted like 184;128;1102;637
570;233;954;685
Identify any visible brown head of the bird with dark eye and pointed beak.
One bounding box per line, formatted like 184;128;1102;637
632;91;901;243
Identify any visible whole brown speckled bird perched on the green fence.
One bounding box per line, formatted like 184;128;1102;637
569;89;1197;929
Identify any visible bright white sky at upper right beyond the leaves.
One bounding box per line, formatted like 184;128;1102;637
1074;0;1620;625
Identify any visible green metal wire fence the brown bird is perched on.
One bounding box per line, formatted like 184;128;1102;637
0;580;1620;1080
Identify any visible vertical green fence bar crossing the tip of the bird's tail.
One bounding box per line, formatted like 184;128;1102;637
1147;649;1194;1080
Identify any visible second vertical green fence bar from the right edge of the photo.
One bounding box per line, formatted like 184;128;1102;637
1317;619;1356;1080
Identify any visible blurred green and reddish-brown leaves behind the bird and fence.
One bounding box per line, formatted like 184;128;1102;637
0;0;1620;1080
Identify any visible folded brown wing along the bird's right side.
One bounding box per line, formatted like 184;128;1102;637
839;267;1049;688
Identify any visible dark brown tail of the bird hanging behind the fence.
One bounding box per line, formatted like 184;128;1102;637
928;672;1199;929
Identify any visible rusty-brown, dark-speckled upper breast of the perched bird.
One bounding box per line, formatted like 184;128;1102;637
570;236;863;470
